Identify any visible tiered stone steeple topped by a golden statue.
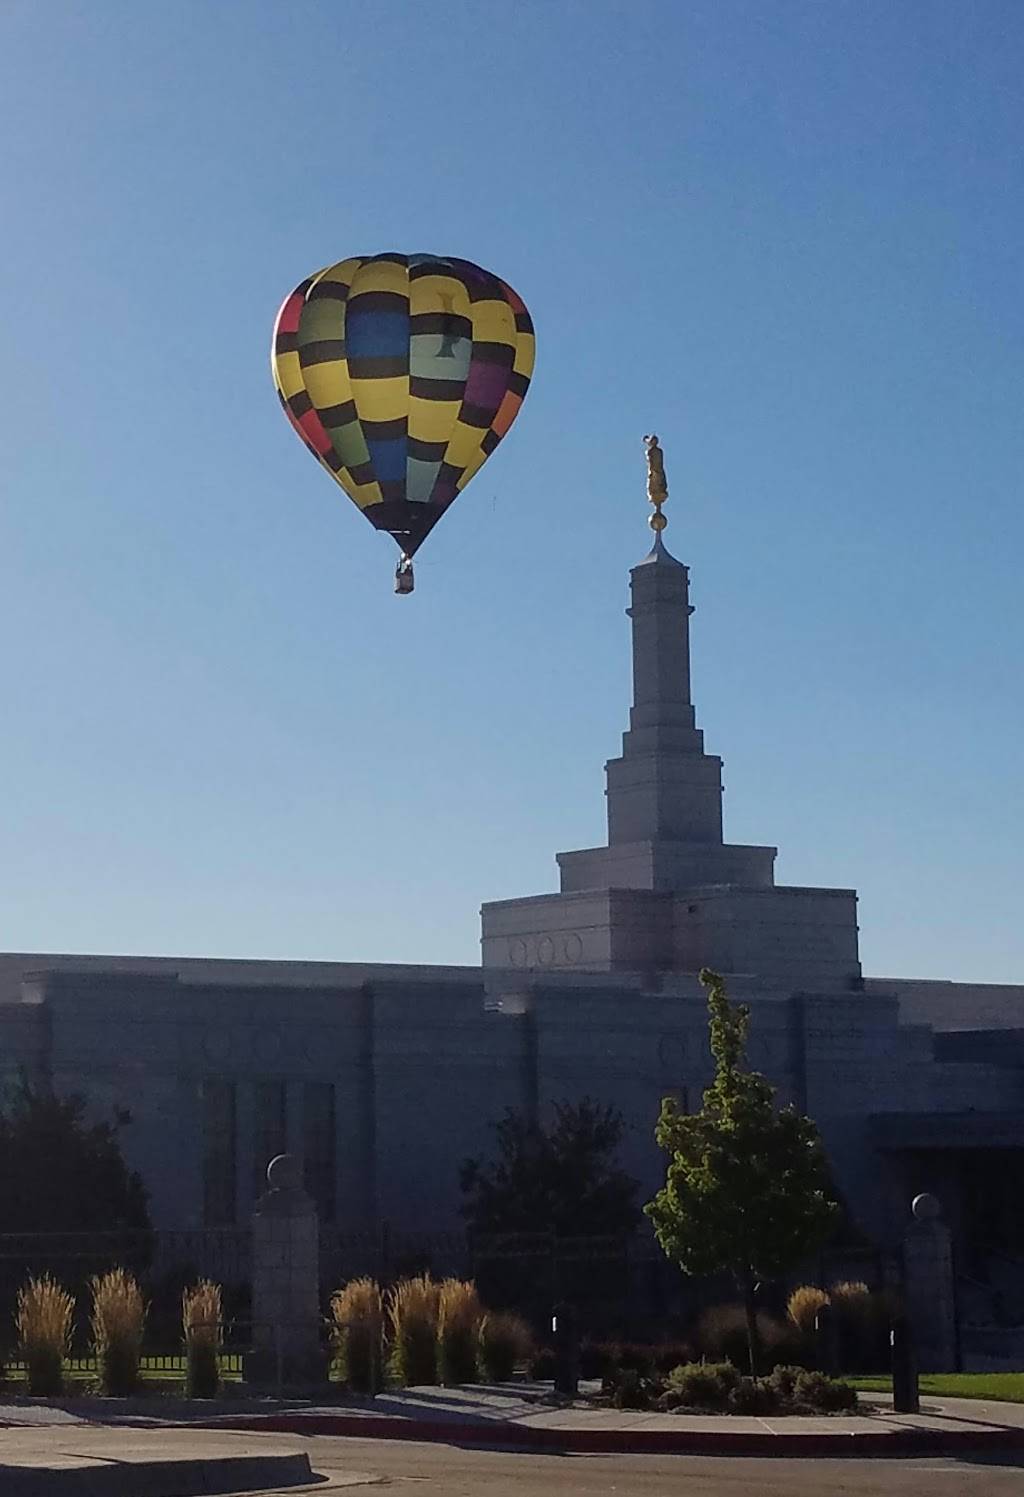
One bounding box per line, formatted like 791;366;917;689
481;437;861;991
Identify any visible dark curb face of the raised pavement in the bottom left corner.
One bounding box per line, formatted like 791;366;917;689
0;1454;316;1497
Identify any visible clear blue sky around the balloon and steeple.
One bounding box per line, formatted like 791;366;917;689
0;0;1024;981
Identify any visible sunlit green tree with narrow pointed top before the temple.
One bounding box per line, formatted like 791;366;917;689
644;969;838;1374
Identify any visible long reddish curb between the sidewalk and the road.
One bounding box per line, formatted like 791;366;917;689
205;1413;1024;1458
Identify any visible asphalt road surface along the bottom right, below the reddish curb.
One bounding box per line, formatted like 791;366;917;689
301;1437;1024;1497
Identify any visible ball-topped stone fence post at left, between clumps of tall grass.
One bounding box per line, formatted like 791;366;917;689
246;1154;328;1388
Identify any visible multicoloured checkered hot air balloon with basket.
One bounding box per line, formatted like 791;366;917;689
271;254;534;593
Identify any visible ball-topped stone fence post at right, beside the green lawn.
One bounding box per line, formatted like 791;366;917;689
903;1195;958;1373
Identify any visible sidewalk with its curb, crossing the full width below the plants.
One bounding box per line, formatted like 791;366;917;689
0;1383;1024;1455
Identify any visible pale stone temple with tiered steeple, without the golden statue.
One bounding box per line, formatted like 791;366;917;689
0;452;1024;1347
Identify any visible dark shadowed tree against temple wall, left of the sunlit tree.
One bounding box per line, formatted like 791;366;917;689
460;1097;639;1237
